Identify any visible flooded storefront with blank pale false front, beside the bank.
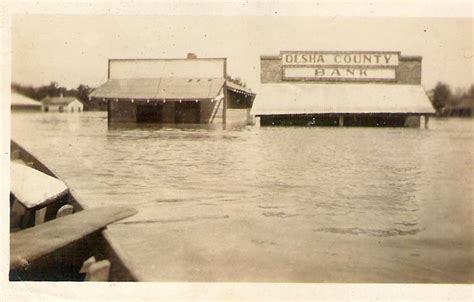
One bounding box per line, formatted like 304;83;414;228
89;55;255;125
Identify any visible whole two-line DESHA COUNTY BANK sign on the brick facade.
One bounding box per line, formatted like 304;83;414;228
281;51;400;81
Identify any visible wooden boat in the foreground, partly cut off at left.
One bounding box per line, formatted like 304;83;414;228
10;141;136;281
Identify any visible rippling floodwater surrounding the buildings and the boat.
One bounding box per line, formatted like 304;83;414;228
12;112;474;283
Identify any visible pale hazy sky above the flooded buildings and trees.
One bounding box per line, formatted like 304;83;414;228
11;14;473;93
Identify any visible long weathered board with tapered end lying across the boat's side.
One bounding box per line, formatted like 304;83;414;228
10;207;137;270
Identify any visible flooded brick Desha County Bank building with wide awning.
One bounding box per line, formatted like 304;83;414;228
252;51;435;127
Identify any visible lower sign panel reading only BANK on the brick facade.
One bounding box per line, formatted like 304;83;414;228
283;67;395;81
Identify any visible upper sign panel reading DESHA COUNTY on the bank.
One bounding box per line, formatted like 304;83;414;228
281;51;399;66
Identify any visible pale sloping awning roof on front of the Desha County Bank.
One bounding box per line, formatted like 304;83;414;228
252;83;435;115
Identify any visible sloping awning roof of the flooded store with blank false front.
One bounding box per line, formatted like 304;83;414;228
90;78;229;99
